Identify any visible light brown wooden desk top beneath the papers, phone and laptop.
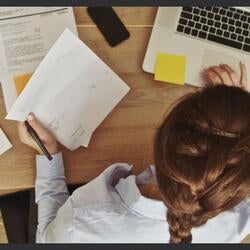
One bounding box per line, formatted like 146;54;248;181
0;7;191;194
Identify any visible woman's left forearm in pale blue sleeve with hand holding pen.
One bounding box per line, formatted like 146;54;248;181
18;115;69;235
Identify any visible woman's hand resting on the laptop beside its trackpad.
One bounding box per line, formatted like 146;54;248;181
203;63;247;89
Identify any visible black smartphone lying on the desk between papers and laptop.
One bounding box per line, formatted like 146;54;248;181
87;7;129;47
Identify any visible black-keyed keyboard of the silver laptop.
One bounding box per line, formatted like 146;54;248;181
177;7;250;52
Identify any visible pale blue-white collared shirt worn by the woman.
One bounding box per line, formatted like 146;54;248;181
35;153;250;243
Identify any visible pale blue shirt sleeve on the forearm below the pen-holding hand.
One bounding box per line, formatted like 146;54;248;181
35;153;69;236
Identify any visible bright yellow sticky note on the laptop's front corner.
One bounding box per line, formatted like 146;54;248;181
155;53;186;85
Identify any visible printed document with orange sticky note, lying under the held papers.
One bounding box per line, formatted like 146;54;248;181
0;7;77;112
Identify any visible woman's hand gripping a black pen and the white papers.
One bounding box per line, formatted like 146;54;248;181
18;114;59;154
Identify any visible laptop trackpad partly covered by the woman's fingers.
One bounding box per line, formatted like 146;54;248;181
198;49;240;84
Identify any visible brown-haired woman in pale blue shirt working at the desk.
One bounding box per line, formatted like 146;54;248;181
19;64;250;243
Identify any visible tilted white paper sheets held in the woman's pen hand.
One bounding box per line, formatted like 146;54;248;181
6;29;129;150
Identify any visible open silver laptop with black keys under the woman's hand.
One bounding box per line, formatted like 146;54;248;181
143;7;250;90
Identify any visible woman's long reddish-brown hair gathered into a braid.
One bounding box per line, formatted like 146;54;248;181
154;85;250;243
